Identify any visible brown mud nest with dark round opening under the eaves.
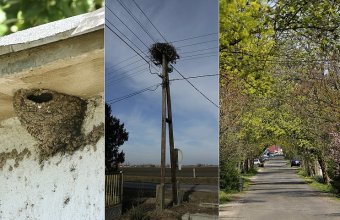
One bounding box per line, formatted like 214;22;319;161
13;89;87;162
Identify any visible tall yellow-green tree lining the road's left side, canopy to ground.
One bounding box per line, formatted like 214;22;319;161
220;0;274;190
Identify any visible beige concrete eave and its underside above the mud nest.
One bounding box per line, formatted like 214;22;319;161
0;19;104;121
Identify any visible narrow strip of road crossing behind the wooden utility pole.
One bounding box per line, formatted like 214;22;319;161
124;182;218;193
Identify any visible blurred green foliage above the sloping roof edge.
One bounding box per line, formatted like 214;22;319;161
0;0;103;36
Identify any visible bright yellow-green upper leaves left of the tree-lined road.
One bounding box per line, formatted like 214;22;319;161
220;0;274;95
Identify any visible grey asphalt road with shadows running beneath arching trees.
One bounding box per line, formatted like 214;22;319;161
220;159;340;220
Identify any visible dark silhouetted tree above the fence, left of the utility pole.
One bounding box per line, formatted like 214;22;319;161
105;103;129;172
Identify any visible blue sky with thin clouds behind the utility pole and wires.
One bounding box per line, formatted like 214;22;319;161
105;0;219;164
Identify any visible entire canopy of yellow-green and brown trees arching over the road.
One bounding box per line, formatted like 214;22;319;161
220;0;340;192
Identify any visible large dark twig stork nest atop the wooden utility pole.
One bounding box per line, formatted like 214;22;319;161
149;43;179;66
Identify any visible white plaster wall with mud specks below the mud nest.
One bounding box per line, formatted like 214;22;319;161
0;96;105;220
